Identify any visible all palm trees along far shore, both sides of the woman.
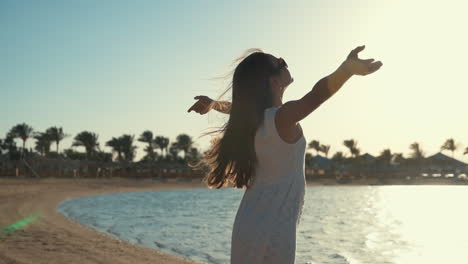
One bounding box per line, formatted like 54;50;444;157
0;123;468;164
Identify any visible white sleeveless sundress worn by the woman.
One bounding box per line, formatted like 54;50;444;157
231;106;307;264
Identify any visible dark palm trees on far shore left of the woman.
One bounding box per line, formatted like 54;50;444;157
0;123;201;162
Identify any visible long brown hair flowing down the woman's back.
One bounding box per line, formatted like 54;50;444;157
189;49;276;189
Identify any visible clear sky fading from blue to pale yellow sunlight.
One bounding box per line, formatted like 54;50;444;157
0;0;468;162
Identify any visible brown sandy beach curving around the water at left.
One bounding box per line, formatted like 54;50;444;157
0;178;206;264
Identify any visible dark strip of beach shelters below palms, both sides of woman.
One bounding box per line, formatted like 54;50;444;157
0;152;468;183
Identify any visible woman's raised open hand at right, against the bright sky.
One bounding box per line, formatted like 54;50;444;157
340;45;383;75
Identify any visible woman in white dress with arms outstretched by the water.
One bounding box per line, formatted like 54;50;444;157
188;46;382;264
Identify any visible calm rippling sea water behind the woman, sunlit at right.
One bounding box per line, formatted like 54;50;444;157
57;186;468;264
